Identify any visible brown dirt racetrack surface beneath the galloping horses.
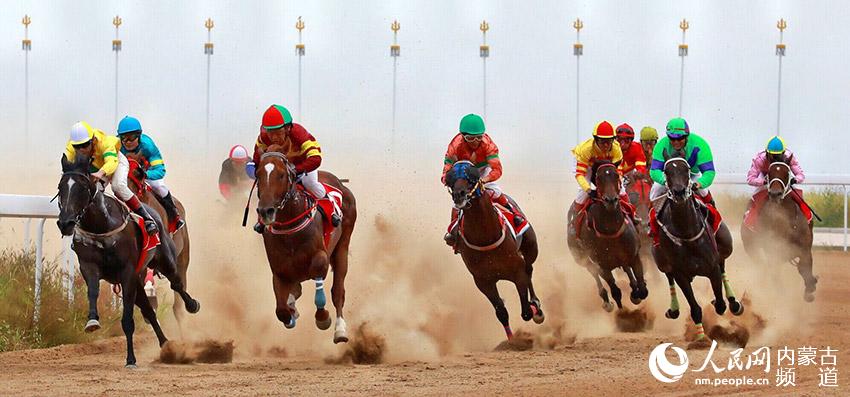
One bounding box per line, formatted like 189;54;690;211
0;253;850;396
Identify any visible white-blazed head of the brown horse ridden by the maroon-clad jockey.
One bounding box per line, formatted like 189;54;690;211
257;145;296;224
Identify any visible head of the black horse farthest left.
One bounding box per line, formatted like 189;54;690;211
56;154;97;236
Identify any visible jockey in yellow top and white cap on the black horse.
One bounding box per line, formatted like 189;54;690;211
65;121;159;250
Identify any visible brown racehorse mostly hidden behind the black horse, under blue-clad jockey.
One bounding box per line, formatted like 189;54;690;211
127;158;189;332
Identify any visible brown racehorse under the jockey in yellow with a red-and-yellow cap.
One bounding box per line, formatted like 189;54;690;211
567;160;649;312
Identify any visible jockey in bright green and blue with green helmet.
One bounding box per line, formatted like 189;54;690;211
649;117;715;206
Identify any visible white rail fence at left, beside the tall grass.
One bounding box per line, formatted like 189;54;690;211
0;194;76;322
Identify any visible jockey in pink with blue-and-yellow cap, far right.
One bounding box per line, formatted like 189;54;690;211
744;136;812;230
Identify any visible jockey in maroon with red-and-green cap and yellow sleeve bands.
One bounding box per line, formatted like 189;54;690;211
245;105;342;234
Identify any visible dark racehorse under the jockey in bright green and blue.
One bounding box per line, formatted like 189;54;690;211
650;151;744;344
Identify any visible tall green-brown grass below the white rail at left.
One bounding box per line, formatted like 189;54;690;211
0;250;122;352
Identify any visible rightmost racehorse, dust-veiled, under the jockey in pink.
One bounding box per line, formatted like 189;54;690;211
741;162;818;302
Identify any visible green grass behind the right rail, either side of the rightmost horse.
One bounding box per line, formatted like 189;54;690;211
715;188;844;227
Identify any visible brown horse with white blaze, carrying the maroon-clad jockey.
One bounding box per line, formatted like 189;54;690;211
257;145;357;343
